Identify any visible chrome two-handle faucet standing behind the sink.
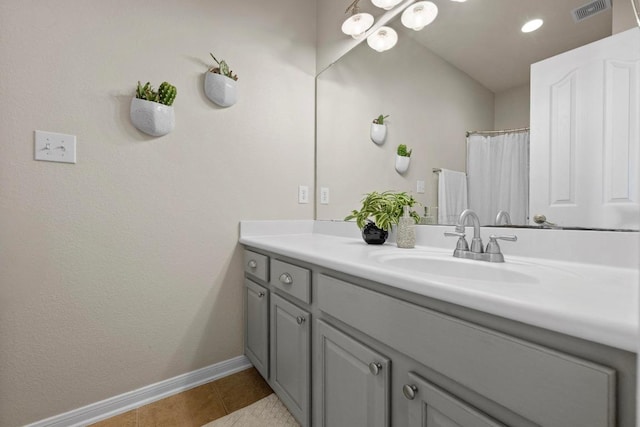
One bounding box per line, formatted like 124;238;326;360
444;209;518;262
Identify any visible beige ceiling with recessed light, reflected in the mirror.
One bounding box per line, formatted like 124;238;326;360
352;0;612;93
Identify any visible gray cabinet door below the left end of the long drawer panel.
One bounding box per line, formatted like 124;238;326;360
315;321;391;427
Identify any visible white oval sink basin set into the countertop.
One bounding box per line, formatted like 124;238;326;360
371;250;576;284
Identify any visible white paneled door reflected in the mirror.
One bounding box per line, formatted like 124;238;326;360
530;28;640;230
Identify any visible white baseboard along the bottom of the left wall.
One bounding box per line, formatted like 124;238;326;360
25;356;252;427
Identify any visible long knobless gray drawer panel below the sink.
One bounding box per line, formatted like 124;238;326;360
317;275;615;427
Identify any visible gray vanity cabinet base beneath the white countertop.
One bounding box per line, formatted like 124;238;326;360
245;244;637;427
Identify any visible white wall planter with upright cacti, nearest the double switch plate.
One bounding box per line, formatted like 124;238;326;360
130;81;178;136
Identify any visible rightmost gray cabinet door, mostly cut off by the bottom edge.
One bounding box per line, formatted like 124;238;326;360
402;373;505;427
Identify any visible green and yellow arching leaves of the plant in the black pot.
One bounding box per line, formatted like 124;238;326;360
344;191;420;231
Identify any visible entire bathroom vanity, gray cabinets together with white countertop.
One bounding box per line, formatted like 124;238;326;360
240;221;638;427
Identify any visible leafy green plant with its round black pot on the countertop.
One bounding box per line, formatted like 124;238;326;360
344;191;420;245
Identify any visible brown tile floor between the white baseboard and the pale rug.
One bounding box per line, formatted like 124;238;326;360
91;368;273;427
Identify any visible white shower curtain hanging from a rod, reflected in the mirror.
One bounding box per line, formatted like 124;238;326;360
467;131;529;225
